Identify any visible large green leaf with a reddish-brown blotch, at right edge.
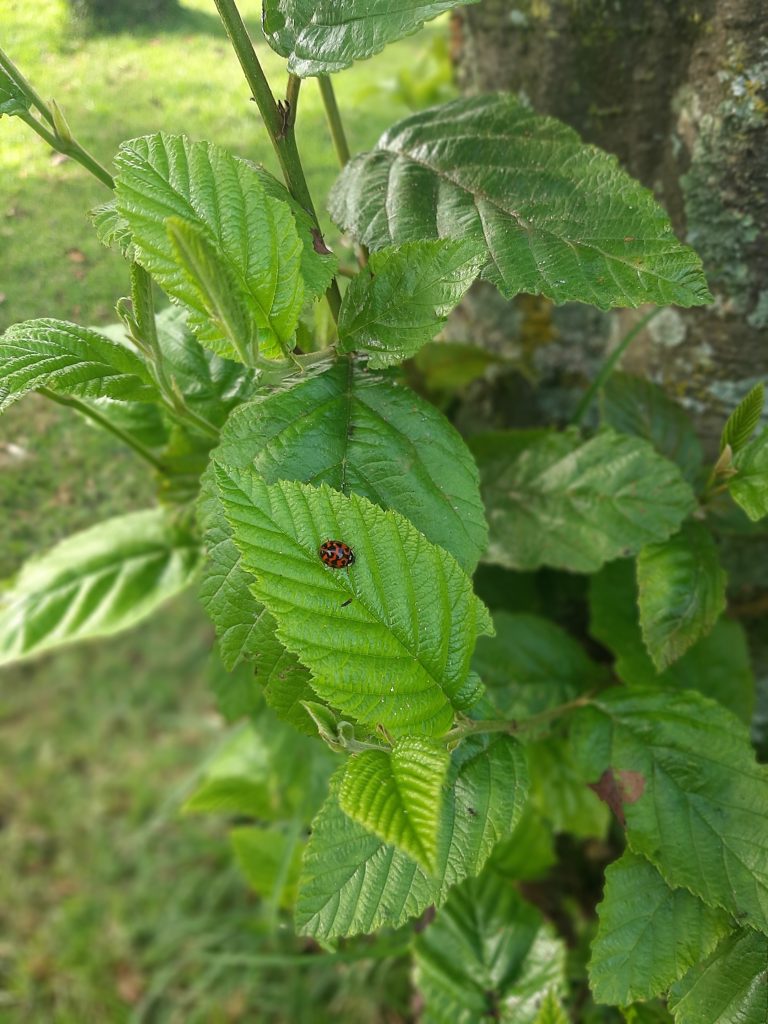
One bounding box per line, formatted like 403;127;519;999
571;690;768;931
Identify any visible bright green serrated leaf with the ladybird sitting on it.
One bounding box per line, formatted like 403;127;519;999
216;466;492;735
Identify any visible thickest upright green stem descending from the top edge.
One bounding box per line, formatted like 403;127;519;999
214;0;341;321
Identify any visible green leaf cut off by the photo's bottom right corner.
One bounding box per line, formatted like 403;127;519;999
669;928;768;1024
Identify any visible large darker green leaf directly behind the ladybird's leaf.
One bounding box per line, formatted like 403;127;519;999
201;359;486;668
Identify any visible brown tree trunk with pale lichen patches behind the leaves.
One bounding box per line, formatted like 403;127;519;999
454;0;768;451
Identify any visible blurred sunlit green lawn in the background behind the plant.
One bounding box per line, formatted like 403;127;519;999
0;0;453;1024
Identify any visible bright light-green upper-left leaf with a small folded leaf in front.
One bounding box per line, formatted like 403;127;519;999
116;132;304;357
